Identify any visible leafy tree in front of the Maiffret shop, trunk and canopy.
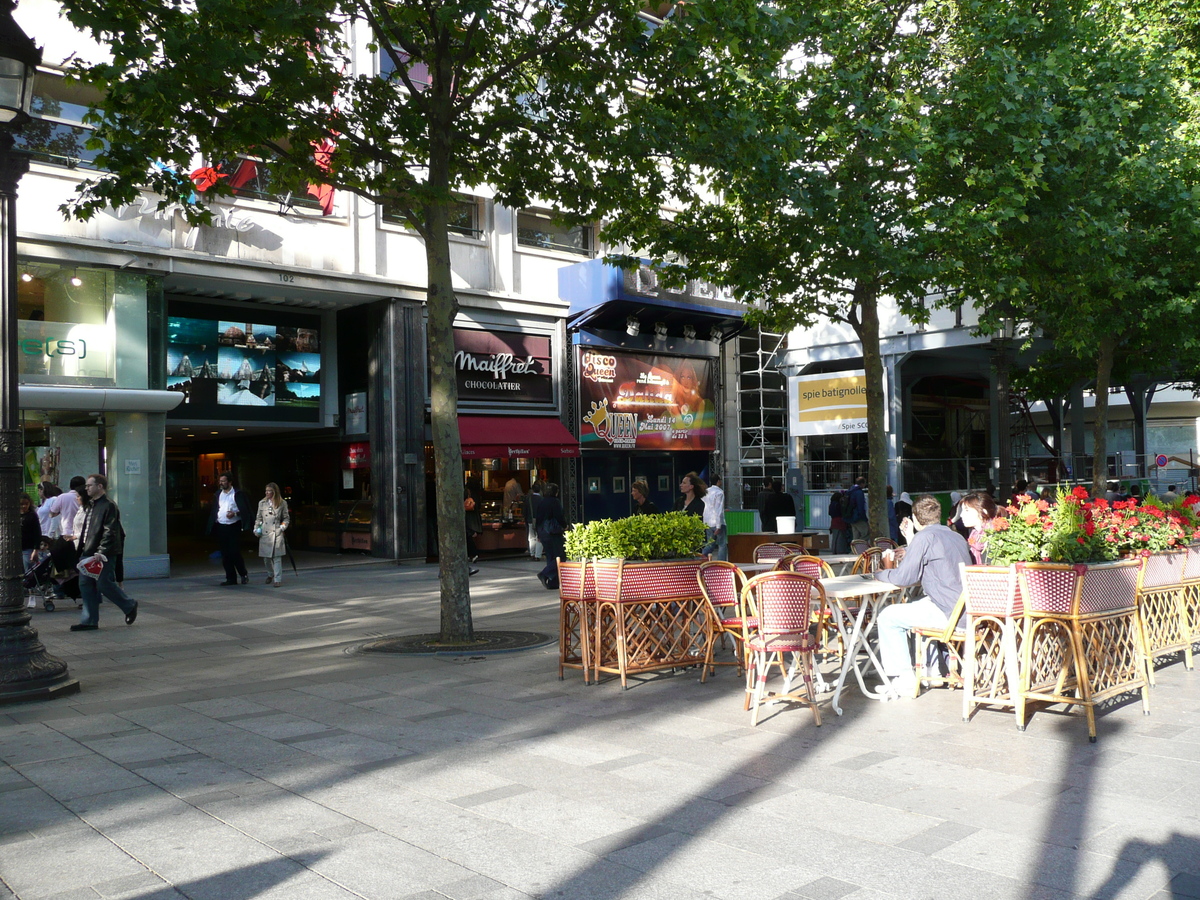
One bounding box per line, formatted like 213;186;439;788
54;0;700;642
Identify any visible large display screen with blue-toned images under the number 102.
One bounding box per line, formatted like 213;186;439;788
167;304;322;421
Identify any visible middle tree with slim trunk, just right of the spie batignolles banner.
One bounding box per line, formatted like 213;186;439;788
617;0;947;535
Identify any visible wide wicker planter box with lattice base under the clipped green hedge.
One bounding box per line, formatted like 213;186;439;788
588;557;708;688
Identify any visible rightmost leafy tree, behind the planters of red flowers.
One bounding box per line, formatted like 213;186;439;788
924;0;1200;492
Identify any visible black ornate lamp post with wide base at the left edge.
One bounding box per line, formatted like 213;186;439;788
0;0;79;703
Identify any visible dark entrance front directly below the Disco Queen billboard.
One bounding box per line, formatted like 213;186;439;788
582;450;708;522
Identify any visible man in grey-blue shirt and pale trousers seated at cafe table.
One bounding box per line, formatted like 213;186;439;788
875;493;972;697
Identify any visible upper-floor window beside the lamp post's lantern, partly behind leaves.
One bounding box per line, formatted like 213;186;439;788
16;71;106;169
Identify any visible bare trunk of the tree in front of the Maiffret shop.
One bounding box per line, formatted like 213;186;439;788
425;149;474;643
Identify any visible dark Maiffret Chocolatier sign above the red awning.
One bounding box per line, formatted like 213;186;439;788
454;328;554;403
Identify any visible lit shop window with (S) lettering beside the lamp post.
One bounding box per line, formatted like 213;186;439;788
17;263;115;385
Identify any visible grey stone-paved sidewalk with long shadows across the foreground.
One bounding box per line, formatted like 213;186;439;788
0;559;1200;900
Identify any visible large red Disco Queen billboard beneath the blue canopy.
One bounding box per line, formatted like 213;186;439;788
580;348;716;450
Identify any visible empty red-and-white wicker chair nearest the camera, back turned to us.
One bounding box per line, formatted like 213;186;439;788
742;572;824;726
